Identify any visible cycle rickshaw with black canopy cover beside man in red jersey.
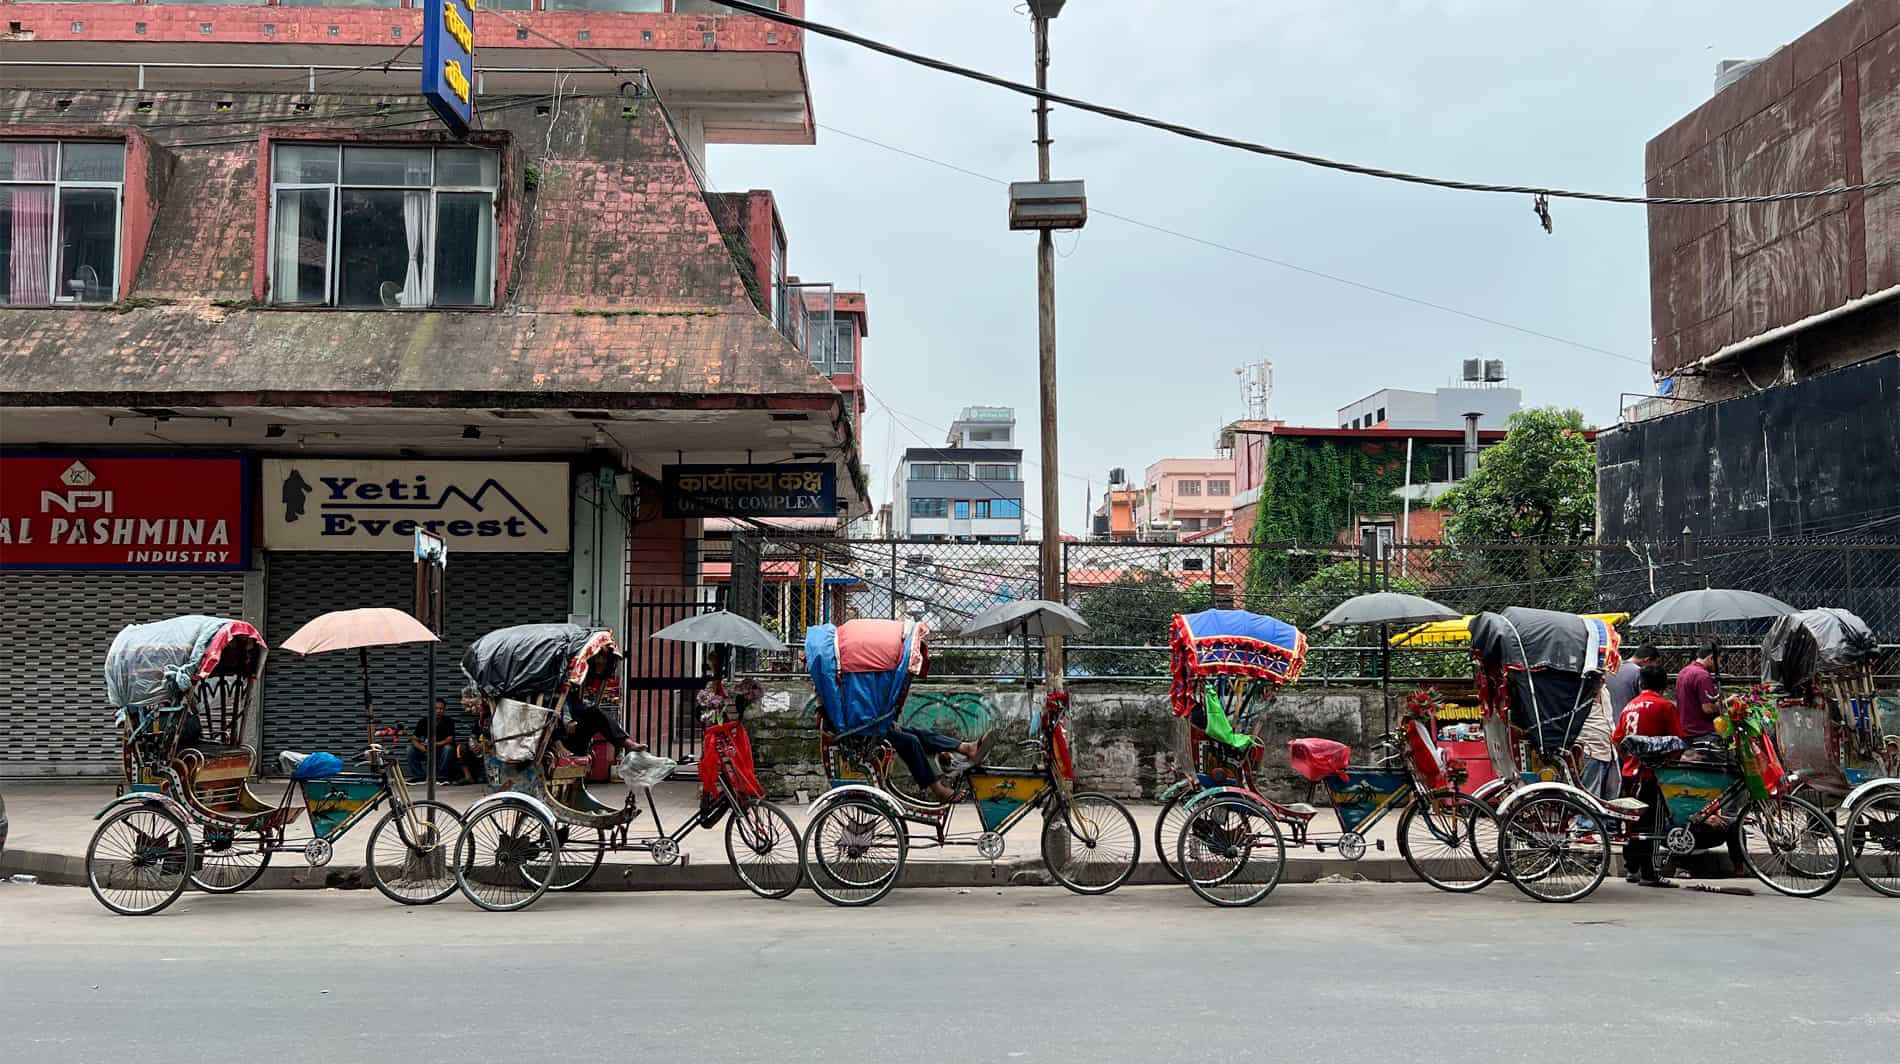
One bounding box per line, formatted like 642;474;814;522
1471;606;1845;903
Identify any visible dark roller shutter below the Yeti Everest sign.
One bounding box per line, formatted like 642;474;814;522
260;551;574;760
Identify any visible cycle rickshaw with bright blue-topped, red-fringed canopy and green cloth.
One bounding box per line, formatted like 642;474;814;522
1157;610;1497;906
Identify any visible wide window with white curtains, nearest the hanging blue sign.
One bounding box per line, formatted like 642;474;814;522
270;144;500;308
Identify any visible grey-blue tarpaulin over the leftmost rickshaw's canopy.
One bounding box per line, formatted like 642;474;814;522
106;614;264;709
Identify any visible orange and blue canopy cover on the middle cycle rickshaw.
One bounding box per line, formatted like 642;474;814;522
806;619;929;737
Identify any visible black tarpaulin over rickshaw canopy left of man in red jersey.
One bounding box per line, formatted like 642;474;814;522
1471;606;1621;754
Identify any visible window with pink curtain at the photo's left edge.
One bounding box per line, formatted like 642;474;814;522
0;141;125;306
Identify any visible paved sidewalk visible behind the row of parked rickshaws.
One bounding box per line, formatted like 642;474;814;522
0;781;1414;891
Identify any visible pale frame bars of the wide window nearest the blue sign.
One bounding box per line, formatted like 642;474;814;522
264;139;505;312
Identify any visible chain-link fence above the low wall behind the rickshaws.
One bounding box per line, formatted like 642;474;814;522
730;536;1900;684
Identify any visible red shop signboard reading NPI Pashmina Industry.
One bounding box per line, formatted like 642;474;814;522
0;452;251;572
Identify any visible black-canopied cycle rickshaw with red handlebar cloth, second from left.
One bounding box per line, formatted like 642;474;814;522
456;625;800;912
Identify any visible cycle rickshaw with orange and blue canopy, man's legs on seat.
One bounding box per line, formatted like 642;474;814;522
804;619;1142;906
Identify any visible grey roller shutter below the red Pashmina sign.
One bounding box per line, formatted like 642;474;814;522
0;572;243;775
